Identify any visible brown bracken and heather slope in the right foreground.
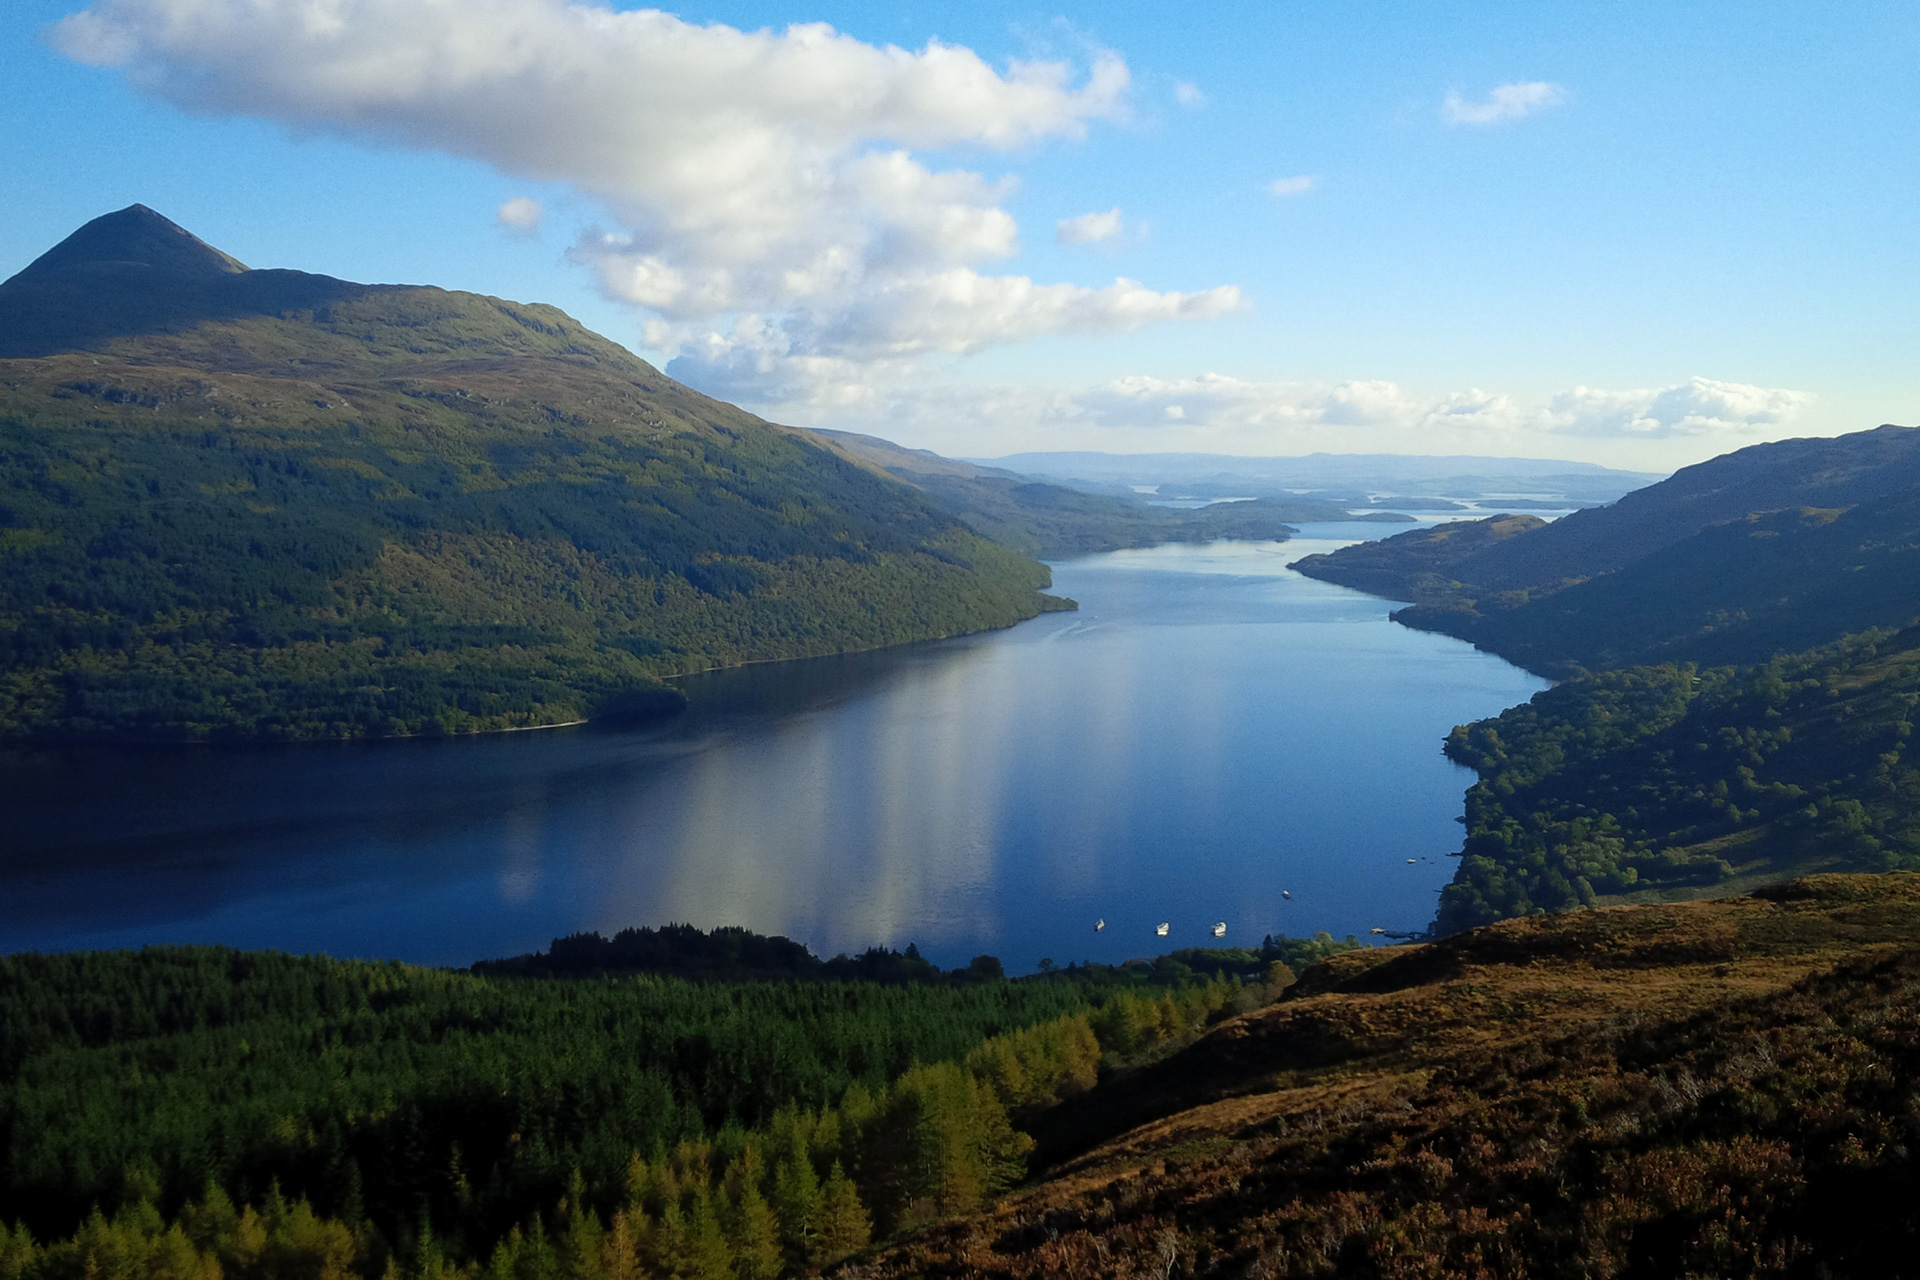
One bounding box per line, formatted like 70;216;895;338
847;873;1920;1280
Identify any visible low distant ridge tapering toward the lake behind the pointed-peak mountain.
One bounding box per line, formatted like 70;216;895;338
818;430;1351;558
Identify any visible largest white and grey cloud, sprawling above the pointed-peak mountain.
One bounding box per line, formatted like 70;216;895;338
52;0;1238;370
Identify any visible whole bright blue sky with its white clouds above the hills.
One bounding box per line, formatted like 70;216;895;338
0;0;1920;470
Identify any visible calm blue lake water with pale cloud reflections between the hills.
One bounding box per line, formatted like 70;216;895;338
0;524;1546;971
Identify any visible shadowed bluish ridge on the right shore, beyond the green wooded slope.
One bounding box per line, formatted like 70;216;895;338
1298;426;1920;676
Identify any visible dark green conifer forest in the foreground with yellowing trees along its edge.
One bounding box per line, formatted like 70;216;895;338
0;931;1297;1280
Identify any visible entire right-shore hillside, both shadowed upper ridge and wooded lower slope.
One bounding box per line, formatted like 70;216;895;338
1296;426;1920;933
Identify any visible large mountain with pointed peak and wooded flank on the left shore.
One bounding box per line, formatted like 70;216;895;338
0;205;1075;739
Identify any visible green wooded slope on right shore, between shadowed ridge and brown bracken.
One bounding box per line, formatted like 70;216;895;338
1436;629;1920;933
